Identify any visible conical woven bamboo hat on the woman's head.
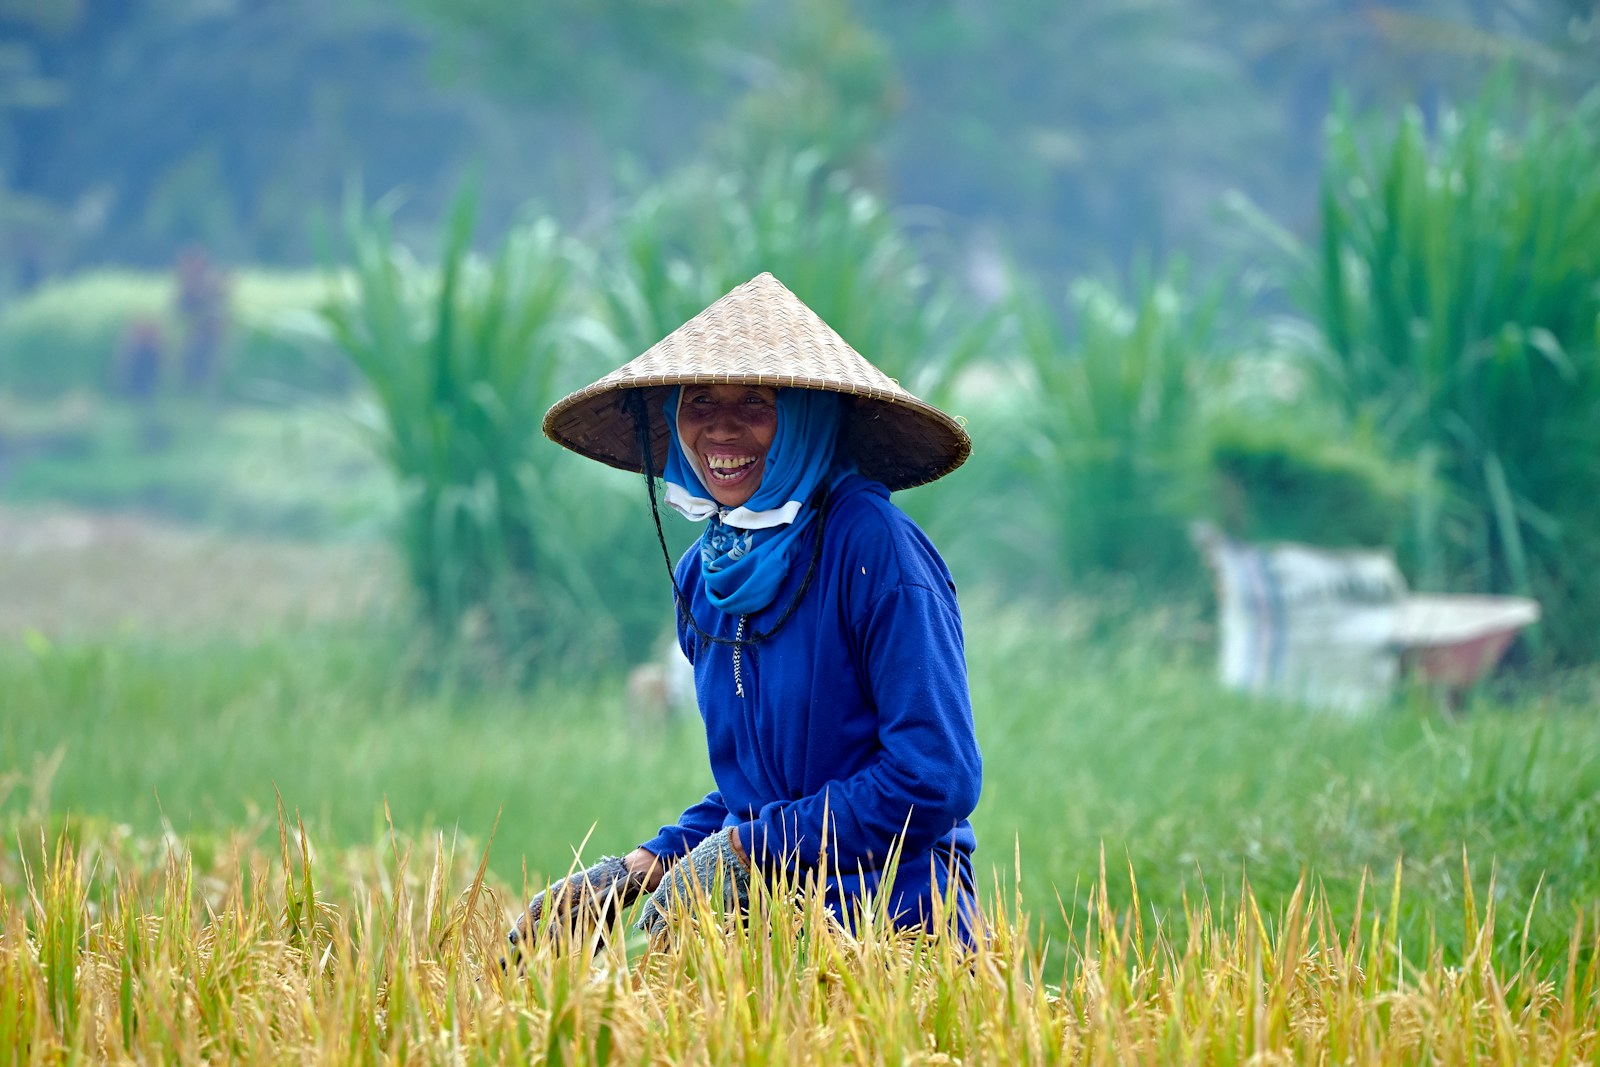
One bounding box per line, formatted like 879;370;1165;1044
544;274;973;490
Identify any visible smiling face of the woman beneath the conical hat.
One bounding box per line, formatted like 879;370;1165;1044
678;386;778;507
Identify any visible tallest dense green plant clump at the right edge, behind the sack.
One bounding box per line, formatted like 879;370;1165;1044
1298;91;1600;661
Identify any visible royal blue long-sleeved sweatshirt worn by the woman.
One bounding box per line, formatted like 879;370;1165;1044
643;475;982;927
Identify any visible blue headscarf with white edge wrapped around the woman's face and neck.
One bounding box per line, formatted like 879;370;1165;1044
662;387;838;614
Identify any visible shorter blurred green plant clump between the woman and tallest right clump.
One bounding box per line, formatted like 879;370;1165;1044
1013;264;1221;589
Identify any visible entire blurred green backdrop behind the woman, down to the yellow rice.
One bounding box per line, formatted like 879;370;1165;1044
0;0;1600;966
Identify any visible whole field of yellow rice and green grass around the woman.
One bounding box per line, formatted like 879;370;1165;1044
0;504;1600;1064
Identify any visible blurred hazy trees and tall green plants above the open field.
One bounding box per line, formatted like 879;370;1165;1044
0;0;1600;673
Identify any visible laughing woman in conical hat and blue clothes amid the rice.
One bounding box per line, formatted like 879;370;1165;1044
510;274;982;944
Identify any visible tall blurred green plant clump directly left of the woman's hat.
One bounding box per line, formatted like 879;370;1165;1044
323;187;654;672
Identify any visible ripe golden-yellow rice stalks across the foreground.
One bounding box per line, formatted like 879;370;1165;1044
0;827;1600;1064
